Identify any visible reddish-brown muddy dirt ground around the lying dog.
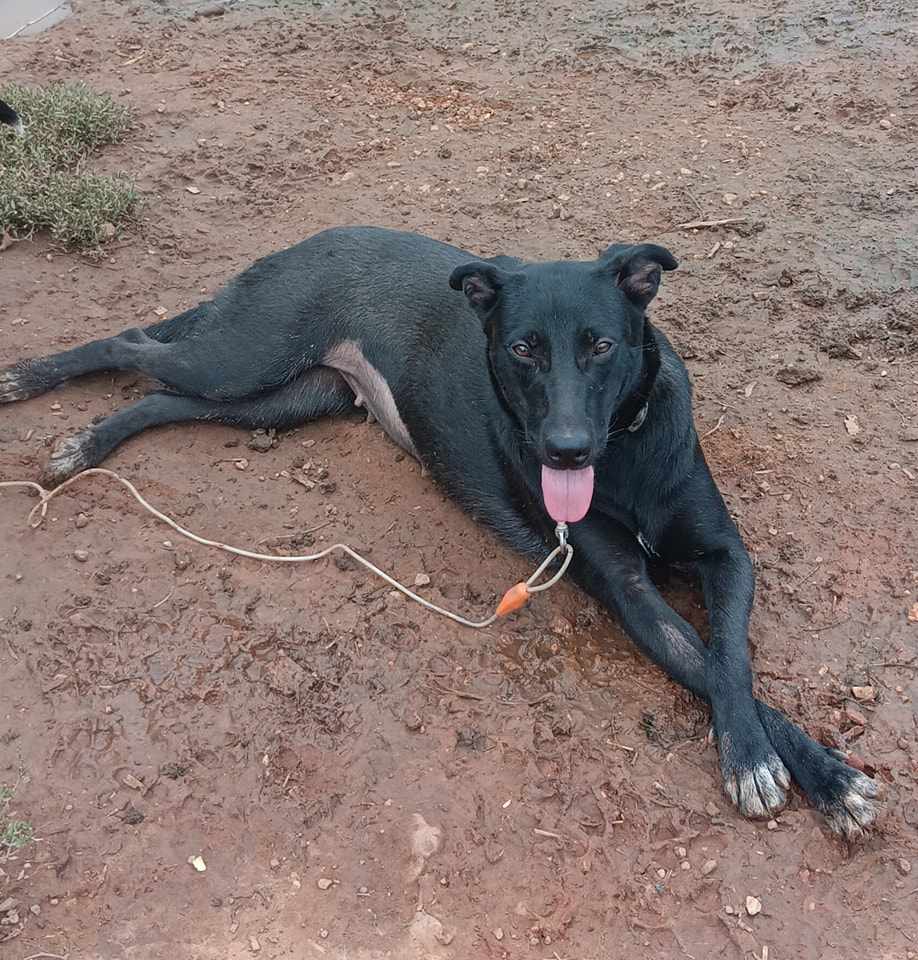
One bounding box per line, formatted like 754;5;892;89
0;0;918;960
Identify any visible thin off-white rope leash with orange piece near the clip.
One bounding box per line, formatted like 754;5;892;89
0;467;574;630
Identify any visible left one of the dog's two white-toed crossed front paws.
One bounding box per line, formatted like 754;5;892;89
717;727;790;820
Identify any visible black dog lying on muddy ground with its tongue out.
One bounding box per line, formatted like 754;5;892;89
0;227;876;837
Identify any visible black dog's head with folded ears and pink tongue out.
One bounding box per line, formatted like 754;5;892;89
449;243;677;520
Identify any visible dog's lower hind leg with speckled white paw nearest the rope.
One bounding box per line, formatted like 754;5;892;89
44;367;354;484
